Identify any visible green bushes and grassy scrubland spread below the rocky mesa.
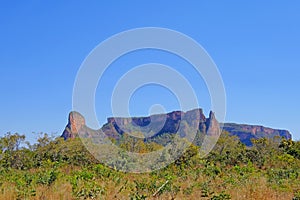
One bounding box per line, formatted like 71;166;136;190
0;133;300;200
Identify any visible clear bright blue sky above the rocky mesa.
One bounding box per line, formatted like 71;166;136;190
0;0;300;139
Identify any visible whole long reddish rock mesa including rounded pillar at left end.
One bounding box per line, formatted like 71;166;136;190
61;109;291;146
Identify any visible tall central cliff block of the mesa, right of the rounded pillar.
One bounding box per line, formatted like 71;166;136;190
102;109;220;137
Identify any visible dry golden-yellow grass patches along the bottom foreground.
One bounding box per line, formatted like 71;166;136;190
0;167;293;200
